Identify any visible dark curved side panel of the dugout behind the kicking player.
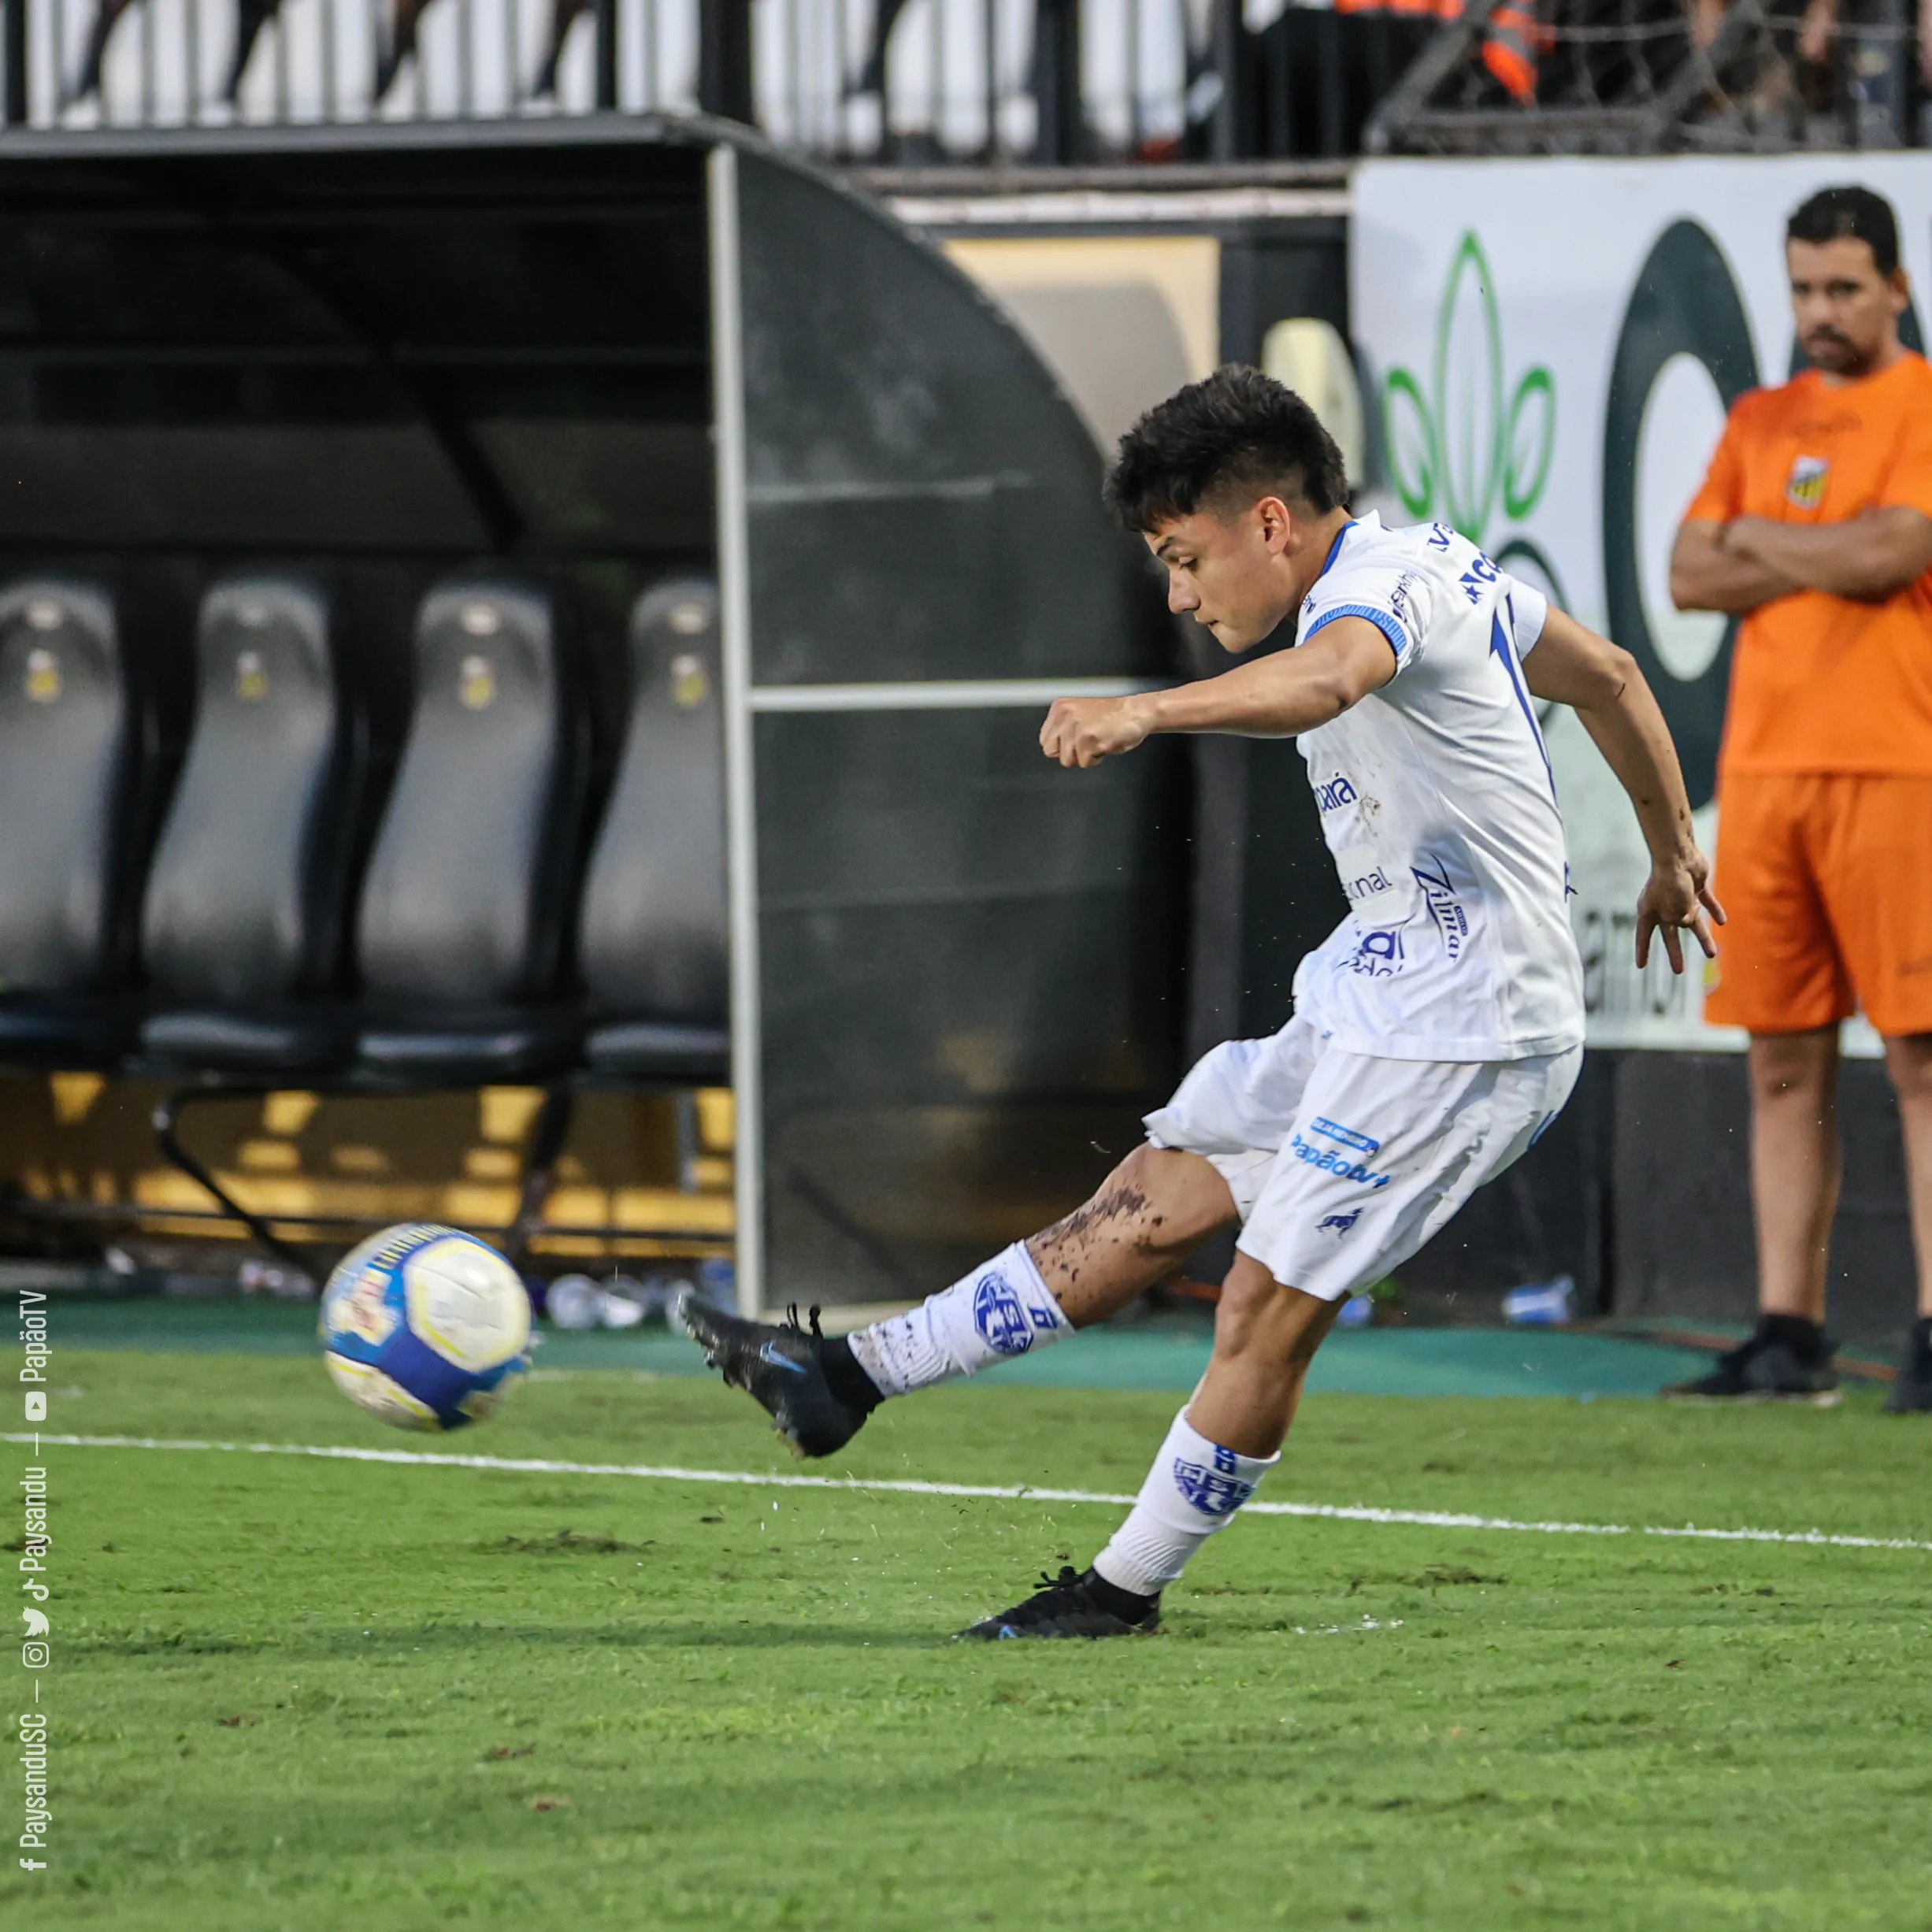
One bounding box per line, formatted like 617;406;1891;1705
740;157;1190;1306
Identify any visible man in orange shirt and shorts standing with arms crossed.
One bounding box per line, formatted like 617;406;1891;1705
1671;187;1932;1412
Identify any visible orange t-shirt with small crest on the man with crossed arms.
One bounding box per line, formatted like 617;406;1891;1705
1685;351;1932;777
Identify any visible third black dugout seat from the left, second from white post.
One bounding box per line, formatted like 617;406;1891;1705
355;580;588;1086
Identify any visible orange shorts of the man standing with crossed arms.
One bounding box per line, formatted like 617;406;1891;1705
1704;773;1932;1033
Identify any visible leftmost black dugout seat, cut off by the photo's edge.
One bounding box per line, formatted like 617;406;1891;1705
0;576;161;1066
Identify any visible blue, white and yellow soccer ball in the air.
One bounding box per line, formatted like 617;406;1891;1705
321;1221;529;1430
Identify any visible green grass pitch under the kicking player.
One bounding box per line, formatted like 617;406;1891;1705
22;1351;1932;1932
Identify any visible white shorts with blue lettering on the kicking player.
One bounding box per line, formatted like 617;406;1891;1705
1146;1016;1582;1302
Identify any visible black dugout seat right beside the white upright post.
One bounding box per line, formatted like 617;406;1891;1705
577;577;730;1084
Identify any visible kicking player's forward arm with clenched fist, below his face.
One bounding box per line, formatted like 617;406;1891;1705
1040;617;1395;767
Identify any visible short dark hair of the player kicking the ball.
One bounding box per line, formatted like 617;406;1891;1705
1107;363;1348;532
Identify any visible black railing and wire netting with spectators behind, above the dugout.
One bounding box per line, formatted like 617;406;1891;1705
0;0;1926;160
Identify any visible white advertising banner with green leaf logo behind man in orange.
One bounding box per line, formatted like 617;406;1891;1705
1348;154;1932;1051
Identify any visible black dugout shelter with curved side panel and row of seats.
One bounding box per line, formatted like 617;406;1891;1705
0;120;1185;1306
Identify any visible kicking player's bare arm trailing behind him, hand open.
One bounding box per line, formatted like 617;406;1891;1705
1522;605;1723;972
